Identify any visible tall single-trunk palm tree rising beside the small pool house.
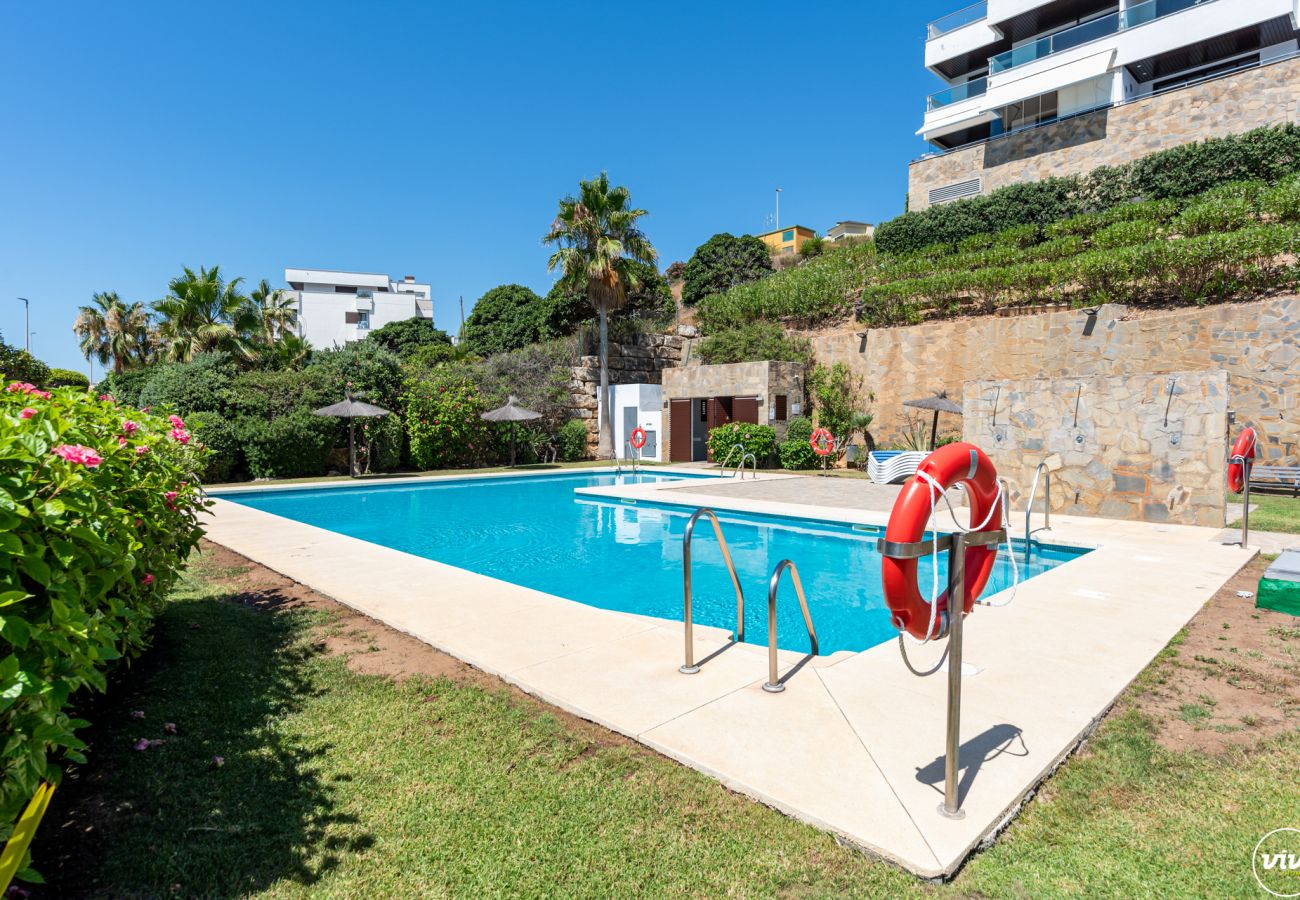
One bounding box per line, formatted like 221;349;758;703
542;172;658;457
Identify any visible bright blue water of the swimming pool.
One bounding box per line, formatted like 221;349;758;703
213;473;1083;653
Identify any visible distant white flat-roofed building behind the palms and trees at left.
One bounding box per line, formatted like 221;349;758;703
285;269;433;350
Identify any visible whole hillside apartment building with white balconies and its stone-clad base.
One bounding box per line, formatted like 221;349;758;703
909;0;1300;209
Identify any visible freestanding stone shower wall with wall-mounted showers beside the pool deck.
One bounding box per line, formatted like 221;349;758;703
962;371;1229;527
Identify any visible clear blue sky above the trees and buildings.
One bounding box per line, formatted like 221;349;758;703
0;0;963;375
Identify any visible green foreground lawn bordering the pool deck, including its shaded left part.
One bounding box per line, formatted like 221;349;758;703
34;563;1300;897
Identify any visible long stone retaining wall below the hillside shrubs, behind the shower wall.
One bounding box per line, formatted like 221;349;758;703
809;295;1300;466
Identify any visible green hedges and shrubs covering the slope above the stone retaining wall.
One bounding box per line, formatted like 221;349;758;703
697;126;1300;334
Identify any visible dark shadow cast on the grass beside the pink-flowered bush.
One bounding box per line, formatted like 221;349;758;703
33;580;373;897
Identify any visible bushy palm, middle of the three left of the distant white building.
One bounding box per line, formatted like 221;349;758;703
153;265;261;363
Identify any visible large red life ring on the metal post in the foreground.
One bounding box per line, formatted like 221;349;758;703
881;442;1002;640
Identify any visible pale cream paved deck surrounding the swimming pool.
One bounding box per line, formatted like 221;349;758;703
208;468;1255;878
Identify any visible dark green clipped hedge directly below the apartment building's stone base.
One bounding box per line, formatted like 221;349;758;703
875;122;1300;254
